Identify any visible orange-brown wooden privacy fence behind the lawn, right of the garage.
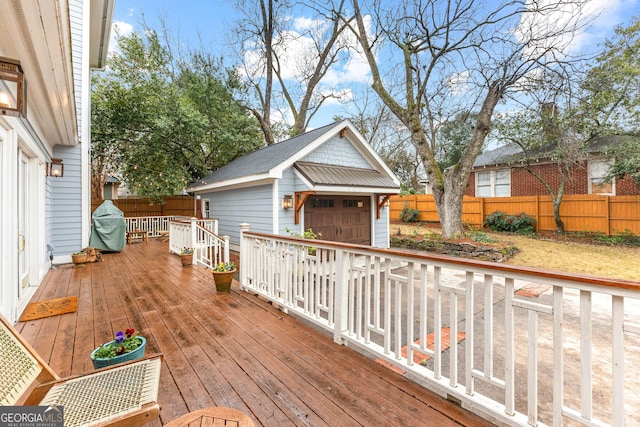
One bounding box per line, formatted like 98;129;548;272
389;194;640;235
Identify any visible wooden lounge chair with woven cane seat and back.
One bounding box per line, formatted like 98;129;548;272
0;315;162;426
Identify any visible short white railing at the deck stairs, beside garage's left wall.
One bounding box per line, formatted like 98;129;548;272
169;218;229;268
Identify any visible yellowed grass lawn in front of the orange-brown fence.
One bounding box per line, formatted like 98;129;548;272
390;223;640;281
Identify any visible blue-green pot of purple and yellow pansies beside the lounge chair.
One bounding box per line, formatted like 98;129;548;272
91;328;147;369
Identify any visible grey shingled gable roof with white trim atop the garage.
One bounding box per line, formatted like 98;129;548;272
187;120;400;192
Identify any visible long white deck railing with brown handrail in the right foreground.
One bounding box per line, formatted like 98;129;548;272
240;224;640;426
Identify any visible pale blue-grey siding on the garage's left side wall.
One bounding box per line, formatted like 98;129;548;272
202;185;273;246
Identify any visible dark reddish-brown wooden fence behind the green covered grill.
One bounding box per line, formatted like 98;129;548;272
91;196;200;217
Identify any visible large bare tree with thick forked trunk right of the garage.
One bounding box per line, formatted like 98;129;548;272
352;0;586;238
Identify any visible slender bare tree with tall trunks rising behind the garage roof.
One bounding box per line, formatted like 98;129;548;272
236;0;354;145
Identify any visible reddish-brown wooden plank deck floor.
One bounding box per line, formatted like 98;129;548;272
16;239;491;427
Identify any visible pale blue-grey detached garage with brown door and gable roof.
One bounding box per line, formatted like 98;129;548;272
187;120;400;249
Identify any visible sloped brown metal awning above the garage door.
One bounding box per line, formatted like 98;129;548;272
294;162;399;189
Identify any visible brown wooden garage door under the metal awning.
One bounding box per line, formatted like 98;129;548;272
304;196;371;245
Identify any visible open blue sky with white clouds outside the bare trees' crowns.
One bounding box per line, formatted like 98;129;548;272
111;0;640;128
